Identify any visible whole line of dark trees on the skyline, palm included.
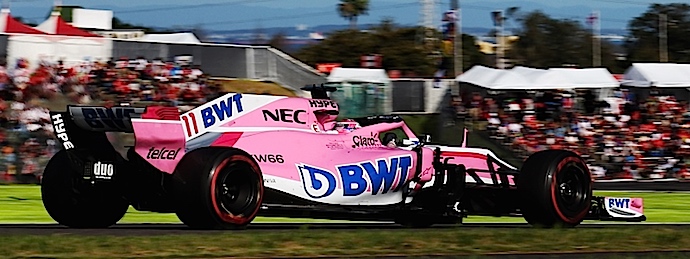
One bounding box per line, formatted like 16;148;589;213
106;0;690;76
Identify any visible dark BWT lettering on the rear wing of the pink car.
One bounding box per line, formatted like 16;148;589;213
81;107;137;130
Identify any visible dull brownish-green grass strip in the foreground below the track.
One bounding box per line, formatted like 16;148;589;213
0;227;690;258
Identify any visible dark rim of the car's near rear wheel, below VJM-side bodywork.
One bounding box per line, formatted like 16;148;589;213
214;162;260;217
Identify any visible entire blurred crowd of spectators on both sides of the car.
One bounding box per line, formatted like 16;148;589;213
0;55;690;182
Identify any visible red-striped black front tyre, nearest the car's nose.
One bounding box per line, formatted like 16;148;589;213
517;150;592;228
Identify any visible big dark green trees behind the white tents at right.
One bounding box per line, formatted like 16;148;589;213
510;3;690;73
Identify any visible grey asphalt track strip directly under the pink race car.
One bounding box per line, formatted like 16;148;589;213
0;222;690;236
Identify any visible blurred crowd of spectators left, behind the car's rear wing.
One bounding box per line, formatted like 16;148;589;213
0;55;218;183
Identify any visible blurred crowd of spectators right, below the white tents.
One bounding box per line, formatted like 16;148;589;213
454;88;690;179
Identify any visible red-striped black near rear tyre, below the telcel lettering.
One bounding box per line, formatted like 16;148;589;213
173;148;264;229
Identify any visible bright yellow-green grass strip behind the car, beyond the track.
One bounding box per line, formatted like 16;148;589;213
0;185;690;224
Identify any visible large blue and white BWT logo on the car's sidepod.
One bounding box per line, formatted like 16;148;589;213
297;155;412;199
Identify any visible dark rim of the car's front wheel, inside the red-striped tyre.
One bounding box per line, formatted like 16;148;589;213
554;162;589;217
